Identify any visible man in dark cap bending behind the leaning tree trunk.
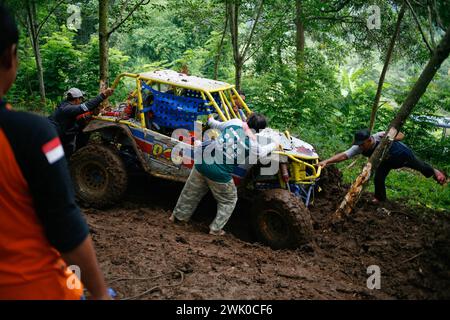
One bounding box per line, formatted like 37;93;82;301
319;129;446;203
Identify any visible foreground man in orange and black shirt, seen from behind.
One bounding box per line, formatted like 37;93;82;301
0;5;110;300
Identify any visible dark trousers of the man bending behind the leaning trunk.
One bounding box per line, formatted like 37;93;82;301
374;155;434;201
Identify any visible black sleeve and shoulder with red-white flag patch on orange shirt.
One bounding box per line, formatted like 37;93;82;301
0;100;89;252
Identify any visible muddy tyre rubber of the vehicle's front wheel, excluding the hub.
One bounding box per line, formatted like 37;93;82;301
251;189;314;249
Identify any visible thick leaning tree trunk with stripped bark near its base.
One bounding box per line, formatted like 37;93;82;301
333;27;450;221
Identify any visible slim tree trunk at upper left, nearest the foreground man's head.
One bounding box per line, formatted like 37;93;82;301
26;1;45;105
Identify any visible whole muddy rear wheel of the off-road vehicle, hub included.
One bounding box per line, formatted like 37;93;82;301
70;144;128;209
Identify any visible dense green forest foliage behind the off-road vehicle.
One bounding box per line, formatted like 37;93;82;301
4;0;450;210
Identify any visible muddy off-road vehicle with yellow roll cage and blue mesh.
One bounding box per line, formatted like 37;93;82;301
70;70;321;248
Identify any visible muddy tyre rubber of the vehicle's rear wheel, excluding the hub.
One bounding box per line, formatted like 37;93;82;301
70;144;128;209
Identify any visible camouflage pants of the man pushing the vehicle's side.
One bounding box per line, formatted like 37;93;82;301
173;168;237;231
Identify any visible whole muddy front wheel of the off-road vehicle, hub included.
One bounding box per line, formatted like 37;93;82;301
251;189;313;249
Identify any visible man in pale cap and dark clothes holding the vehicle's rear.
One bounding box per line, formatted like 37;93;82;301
49;88;114;158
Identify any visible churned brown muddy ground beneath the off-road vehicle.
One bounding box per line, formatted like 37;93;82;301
84;171;450;300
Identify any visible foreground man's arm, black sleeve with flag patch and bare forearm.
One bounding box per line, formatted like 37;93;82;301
10;113;108;299
